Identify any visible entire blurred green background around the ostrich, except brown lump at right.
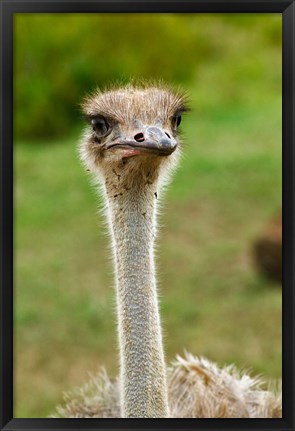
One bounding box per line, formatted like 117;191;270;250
14;14;282;417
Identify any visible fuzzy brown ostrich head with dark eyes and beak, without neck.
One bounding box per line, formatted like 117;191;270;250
80;85;187;188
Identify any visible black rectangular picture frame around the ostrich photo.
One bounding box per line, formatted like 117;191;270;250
0;0;295;431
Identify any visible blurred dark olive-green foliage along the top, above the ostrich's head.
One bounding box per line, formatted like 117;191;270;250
14;14;281;140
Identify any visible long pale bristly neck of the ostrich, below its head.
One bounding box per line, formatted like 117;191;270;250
107;184;168;418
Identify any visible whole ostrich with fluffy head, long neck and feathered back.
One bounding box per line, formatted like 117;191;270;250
52;84;281;418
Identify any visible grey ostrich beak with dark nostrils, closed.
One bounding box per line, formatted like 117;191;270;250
106;126;177;156
